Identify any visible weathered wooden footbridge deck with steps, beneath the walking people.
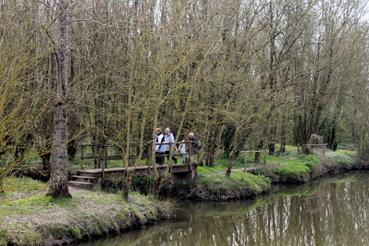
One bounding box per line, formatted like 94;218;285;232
69;164;197;189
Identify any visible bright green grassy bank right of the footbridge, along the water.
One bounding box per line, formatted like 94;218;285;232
183;148;369;201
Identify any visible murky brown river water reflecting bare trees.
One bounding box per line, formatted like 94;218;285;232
84;173;369;246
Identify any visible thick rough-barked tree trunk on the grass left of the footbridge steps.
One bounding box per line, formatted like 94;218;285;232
47;0;71;198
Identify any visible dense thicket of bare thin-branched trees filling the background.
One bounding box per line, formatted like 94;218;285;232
0;0;369;196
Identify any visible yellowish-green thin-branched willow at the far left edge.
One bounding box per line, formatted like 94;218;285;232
0;1;45;192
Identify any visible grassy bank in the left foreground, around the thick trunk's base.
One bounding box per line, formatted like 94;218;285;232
0;178;172;245
